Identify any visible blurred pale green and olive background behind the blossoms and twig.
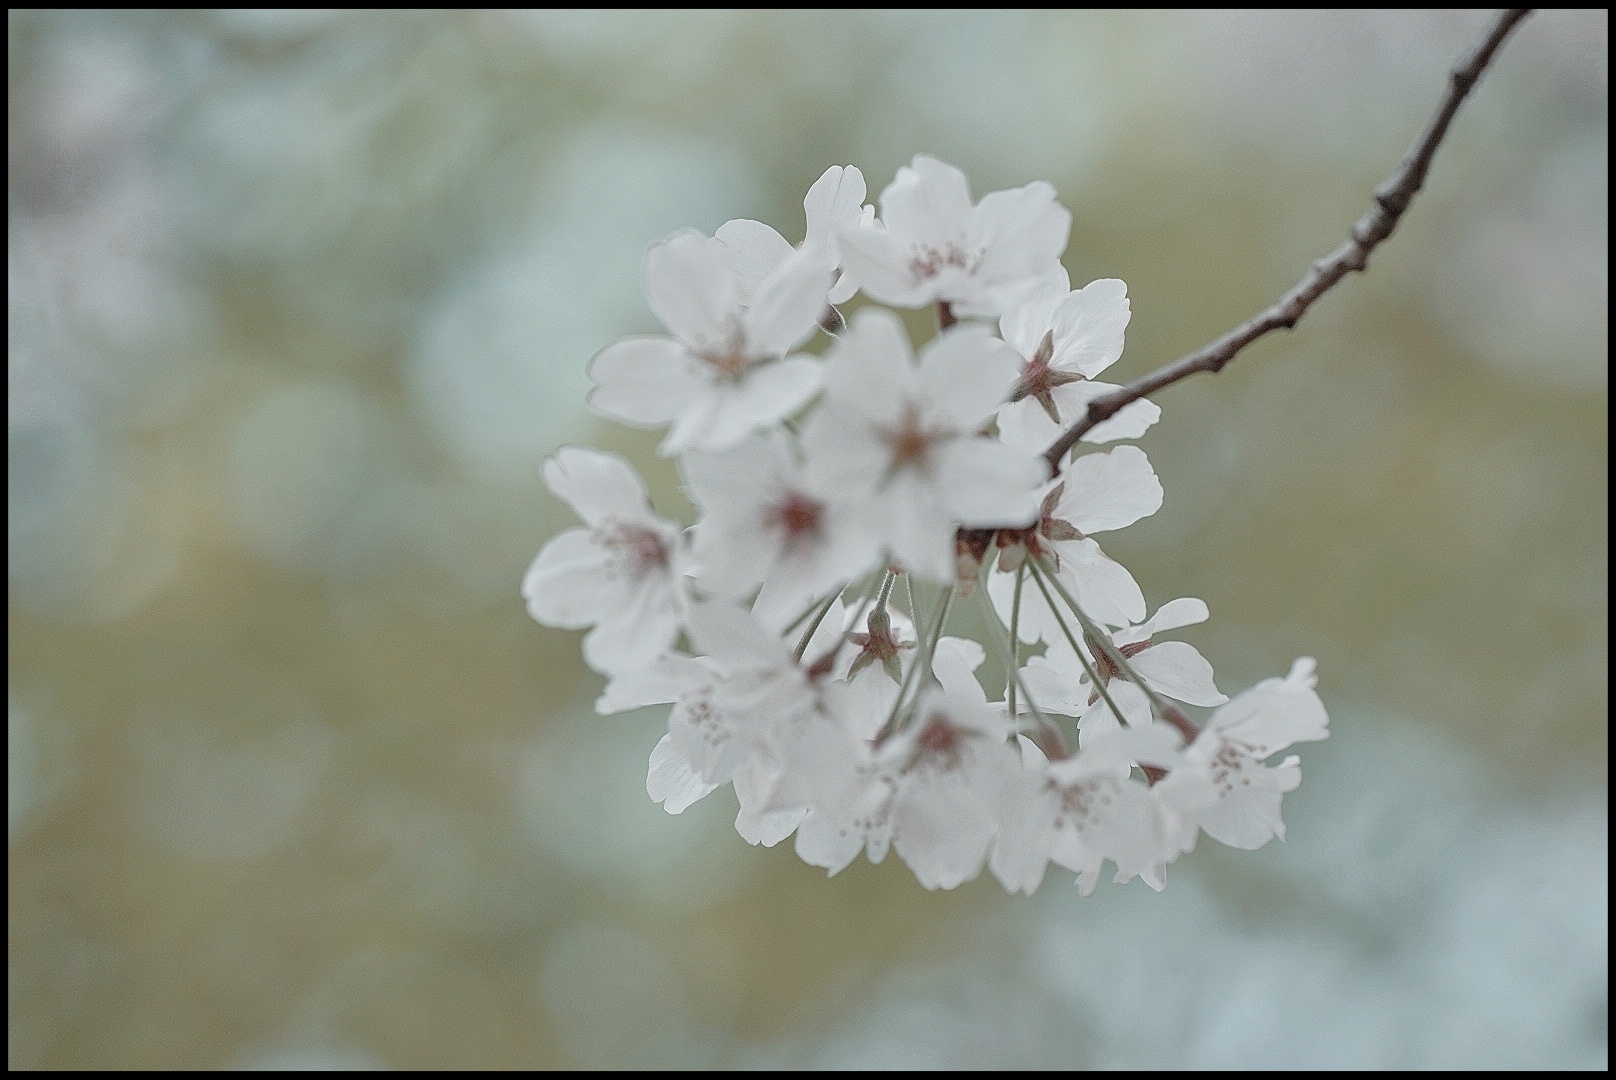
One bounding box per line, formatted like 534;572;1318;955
6;11;1608;1069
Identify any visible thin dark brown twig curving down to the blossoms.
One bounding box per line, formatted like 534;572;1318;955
1044;8;1530;474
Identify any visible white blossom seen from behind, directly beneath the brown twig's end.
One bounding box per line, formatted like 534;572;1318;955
999;265;1162;453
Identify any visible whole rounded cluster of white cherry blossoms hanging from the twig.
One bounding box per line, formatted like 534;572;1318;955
522;155;1328;896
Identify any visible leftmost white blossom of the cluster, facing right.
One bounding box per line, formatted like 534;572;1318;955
522;446;685;674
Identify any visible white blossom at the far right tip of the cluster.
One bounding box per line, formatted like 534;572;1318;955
1154;656;1330;850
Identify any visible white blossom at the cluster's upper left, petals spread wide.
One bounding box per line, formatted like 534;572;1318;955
590;231;831;454
